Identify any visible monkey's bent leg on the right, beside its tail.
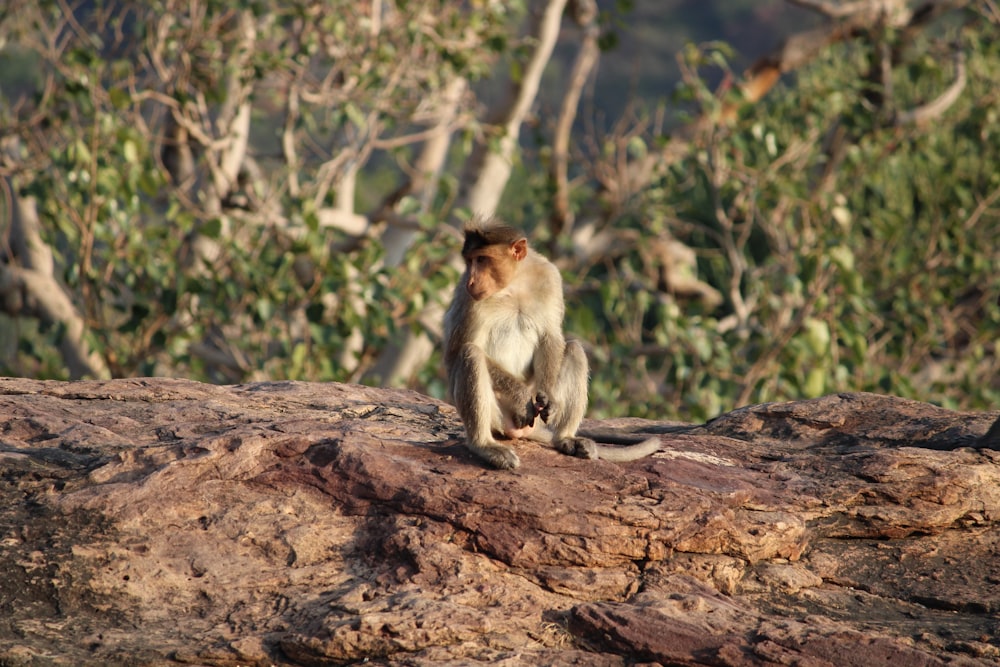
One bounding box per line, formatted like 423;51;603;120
543;340;597;459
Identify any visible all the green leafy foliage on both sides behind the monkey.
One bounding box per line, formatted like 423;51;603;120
0;0;1000;419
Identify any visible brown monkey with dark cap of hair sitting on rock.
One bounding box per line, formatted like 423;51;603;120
444;217;660;470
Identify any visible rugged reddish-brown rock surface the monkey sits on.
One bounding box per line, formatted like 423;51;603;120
0;379;1000;666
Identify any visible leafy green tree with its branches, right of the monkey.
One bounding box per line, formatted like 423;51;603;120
556;2;1000;418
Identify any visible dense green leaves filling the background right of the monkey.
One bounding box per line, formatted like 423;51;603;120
569;26;1000;419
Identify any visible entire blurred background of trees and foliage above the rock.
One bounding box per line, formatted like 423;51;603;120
0;0;1000;420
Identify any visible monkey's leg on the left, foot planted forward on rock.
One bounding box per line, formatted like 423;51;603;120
453;345;521;470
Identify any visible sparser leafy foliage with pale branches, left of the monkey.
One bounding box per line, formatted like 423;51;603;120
0;0;500;382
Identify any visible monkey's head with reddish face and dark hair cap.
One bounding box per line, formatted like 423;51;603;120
462;219;528;301
